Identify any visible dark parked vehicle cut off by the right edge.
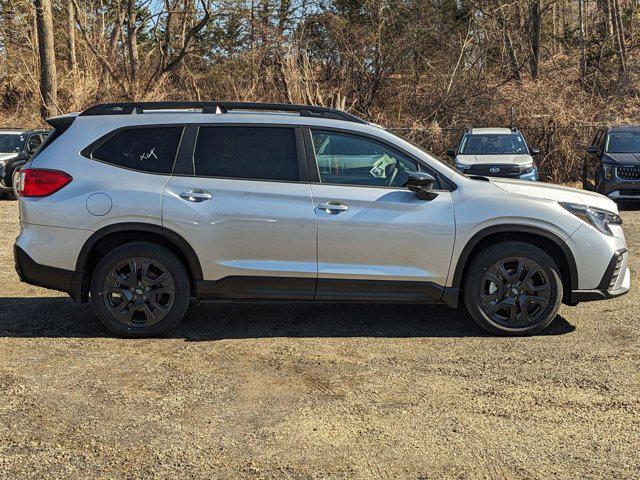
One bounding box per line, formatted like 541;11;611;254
582;126;640;200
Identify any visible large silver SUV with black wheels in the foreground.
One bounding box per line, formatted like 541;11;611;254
15;102;630;336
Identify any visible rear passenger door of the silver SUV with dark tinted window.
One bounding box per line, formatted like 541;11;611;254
163;124;317;300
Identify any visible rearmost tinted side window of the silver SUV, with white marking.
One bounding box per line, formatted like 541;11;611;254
91;127;182;173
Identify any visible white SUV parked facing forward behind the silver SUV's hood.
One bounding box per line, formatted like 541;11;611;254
447;128;540;181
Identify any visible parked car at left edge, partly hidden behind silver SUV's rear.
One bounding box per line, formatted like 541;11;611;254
0;129;49;200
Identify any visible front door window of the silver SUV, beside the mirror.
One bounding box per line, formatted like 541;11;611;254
311;130;418;187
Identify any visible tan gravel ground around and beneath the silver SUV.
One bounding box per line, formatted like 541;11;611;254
0;201;640;479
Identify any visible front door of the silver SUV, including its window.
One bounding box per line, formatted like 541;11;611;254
309;130;455;301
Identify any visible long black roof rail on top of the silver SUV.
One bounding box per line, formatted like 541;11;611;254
80;102;367;123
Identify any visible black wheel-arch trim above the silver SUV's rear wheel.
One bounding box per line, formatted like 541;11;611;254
70;222;203;301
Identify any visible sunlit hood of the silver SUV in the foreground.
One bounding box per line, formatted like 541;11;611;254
489;178;618;213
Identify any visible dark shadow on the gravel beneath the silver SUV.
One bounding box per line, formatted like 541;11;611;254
0;297;575;341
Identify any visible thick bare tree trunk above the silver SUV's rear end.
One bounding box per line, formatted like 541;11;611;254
35;0;58;117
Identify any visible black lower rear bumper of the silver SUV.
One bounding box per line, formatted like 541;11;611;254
13;245;81;301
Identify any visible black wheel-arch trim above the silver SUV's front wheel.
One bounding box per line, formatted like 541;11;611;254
452;223;578;290
